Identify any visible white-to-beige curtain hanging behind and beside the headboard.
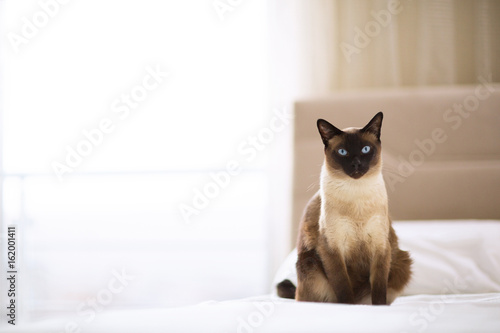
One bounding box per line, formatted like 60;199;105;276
269;0;500;263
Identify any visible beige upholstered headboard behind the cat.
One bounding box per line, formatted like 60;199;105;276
292;84;500;244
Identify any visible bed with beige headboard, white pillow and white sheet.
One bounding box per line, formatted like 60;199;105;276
13;83;500;333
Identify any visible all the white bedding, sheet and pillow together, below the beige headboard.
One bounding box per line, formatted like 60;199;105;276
11;220;500;333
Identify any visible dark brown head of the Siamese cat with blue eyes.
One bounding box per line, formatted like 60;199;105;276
317;112;383;179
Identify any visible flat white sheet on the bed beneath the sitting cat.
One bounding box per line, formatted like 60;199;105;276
12;293;500;333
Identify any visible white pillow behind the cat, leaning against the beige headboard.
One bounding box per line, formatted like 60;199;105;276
273;220;500;295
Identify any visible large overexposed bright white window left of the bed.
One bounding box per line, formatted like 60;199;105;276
0;0;272;321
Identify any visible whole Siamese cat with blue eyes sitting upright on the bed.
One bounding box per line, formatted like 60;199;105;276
278;112;412;305
